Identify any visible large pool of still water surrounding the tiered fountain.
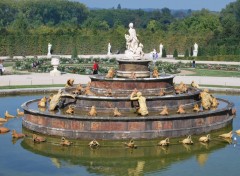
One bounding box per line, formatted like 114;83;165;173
0;94;240;176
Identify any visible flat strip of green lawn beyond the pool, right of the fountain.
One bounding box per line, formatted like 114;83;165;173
183;68;240;77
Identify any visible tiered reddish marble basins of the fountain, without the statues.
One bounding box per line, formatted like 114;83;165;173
22;60;233;140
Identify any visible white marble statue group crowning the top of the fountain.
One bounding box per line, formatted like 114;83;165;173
125;23;144;59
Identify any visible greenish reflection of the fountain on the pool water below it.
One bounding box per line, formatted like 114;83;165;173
21;127;231;176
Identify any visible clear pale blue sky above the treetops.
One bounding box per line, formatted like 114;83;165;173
75;0;237;11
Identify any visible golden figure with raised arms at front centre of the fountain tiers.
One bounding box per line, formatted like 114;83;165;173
130;90;148;116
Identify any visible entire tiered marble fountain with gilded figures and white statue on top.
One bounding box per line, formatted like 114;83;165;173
22;23;234;140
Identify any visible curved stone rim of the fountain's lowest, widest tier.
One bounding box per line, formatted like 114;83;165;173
21;98;234;121
